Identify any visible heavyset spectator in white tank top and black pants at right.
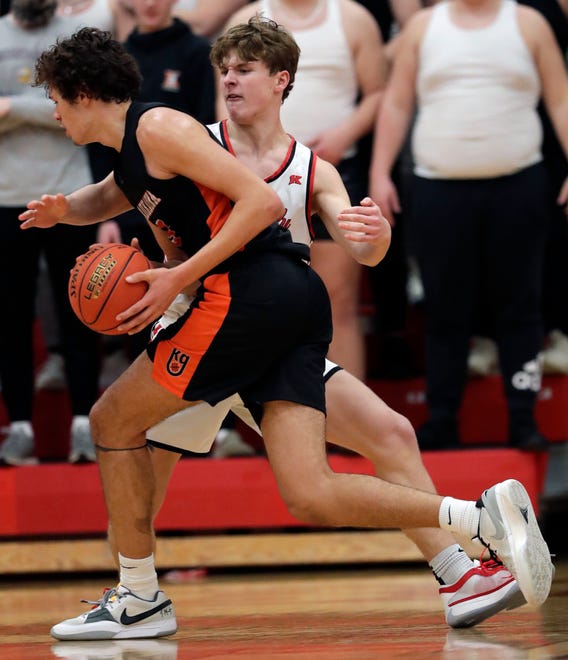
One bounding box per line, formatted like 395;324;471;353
371;0;568;450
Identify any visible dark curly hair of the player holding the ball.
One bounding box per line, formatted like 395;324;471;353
34;27;142;103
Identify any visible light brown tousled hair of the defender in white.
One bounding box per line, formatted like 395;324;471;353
211;14;300;100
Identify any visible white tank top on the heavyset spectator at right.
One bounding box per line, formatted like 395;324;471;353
412;0;542;179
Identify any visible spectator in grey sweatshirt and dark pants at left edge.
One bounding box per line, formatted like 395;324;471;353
0;0;99;465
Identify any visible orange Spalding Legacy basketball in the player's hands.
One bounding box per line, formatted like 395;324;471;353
68;243;152;335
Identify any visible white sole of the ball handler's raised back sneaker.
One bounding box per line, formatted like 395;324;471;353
481;479;553;607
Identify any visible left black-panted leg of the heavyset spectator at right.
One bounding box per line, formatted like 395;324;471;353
412;177;481;450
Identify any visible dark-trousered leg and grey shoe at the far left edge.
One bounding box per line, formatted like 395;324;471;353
0;207;44;465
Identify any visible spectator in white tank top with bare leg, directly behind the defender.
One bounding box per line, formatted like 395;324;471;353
223;0;386;380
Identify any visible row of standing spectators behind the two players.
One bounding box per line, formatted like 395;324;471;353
0;0;568;465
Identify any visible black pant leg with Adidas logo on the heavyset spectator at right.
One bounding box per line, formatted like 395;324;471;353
484;163;549;450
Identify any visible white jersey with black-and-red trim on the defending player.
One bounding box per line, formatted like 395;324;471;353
207;120;317;246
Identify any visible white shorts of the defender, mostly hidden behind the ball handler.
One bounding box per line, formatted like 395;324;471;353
146;294;341;454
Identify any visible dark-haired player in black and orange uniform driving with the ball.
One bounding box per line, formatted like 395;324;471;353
20;25;553;640
